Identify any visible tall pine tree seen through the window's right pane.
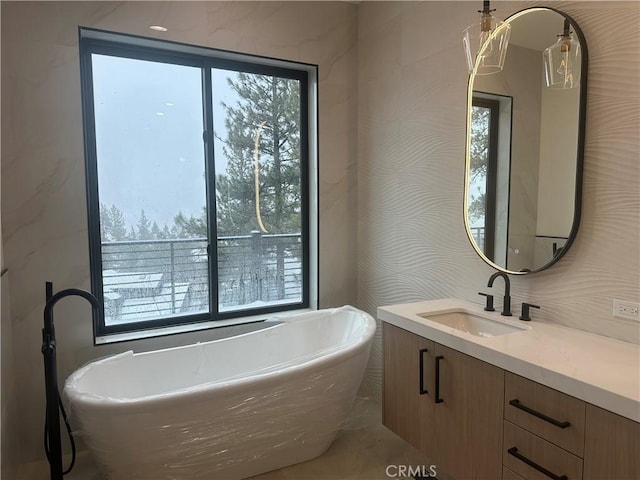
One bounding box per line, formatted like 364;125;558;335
216;73;300;236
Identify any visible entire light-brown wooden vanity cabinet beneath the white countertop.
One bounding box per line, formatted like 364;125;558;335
383;322;640;480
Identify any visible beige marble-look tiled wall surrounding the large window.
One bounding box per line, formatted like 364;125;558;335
2;2;357;462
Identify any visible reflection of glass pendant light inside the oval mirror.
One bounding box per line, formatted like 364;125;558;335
542;19;581;89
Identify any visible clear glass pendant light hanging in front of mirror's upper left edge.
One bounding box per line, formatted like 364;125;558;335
462;0;511;75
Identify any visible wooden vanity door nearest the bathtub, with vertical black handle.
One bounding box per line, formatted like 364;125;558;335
382;323;434;455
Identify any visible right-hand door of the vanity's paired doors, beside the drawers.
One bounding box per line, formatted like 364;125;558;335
434;344;504;480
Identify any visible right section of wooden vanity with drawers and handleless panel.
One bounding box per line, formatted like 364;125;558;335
503;372;640;480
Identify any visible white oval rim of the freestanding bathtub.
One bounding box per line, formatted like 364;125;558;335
63;305;377;411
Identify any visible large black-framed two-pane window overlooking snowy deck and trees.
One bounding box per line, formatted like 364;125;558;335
80;29;315;337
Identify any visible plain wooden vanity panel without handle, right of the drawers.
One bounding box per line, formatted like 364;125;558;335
584;405;640;480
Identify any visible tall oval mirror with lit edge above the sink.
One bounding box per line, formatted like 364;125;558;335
464;7;587;274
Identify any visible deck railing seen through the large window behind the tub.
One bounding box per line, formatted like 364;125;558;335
102;232;302;324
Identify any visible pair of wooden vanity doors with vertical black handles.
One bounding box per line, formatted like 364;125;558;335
383;323;504;479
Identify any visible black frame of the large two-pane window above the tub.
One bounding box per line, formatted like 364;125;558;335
79;27;318;344
